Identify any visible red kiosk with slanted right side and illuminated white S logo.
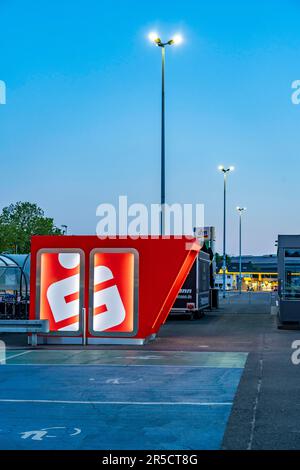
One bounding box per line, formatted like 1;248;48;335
30;235;200;339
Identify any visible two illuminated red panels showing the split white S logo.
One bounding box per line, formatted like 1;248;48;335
39;252;134;333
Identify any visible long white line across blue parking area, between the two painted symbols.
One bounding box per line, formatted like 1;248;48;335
0;398;232;406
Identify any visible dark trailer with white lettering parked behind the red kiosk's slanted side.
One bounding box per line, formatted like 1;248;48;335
170;251;211;318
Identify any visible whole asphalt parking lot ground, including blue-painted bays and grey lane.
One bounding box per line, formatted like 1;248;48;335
0;293;300;449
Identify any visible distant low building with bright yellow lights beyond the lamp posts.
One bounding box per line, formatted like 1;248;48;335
216;255;278;291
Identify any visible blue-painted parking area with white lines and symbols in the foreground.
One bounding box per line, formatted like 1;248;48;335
0;349;247;449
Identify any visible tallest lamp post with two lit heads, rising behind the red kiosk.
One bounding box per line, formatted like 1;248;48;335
149;32;182;235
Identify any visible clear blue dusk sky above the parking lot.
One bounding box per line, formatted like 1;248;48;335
0;0;300;254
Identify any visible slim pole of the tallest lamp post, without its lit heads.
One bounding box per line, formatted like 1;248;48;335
160;46;166;235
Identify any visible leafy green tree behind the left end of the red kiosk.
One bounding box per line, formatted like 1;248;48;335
0;202;62;253
